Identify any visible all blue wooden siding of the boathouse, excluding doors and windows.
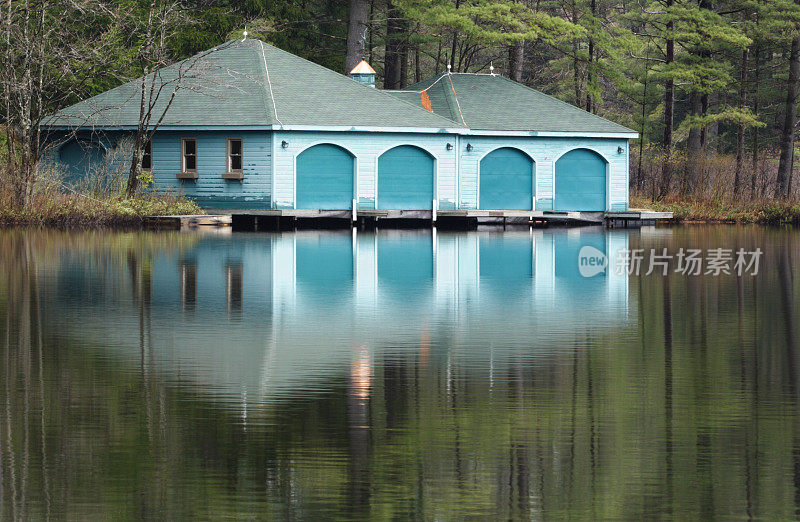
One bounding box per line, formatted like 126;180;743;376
43;130;629;211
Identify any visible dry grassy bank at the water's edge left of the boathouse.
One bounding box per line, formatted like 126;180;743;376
0;192;203;227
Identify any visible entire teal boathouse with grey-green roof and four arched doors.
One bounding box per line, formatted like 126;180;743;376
44;39;637;211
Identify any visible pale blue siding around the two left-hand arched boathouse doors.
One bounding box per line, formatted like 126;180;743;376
274;132;457;210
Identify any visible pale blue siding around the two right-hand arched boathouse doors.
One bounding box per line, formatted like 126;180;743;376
459;136;628;211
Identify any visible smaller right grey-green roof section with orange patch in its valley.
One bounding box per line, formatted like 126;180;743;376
387;73;636;134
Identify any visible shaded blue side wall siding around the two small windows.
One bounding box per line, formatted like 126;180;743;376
153;130;272;209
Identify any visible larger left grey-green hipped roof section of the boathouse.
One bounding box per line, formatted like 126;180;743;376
43;39;457;129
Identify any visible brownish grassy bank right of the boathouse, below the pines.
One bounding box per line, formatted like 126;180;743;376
630;196;800;225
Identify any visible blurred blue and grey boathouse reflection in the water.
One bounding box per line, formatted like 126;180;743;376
53;228;630;400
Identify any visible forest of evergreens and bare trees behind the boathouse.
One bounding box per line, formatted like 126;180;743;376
0;0;800;215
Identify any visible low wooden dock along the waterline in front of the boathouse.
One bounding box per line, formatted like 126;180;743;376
144;209;672;231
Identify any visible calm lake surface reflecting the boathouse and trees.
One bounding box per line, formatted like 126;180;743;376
0;227;800;520
